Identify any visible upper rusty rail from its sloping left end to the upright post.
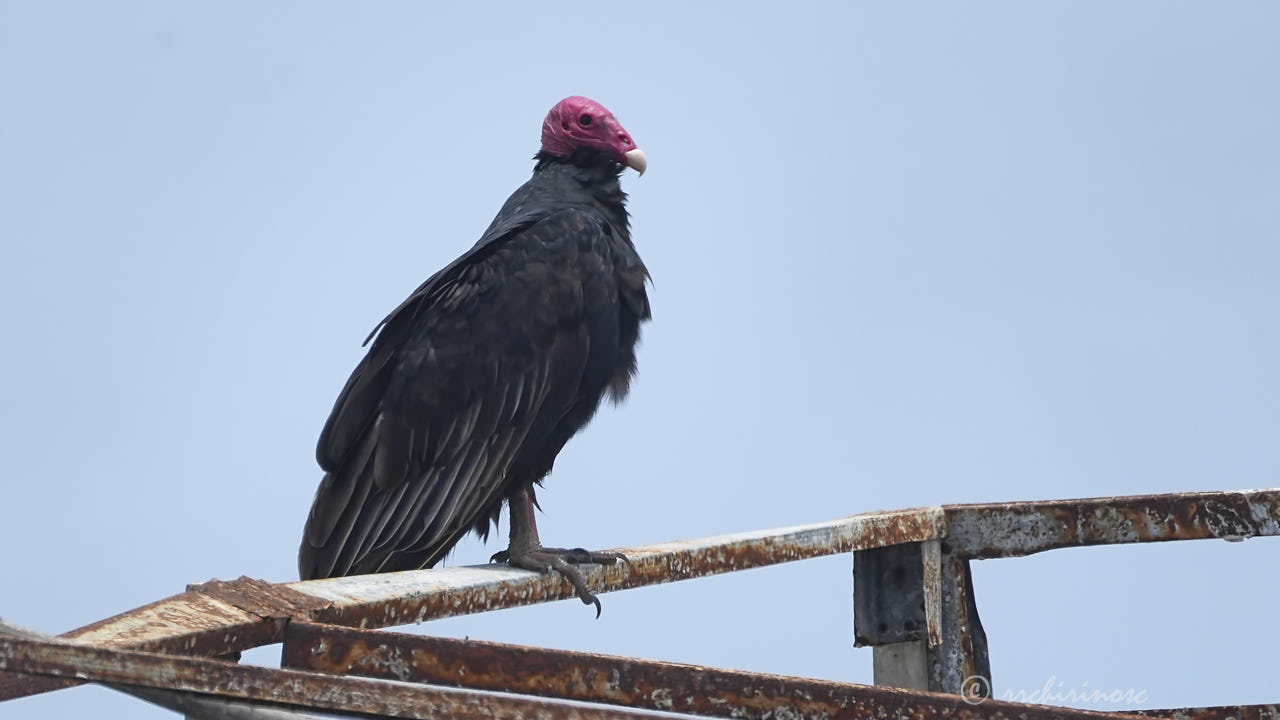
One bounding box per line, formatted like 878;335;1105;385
0;507;942;700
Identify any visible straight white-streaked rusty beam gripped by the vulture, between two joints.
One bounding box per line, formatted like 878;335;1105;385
288;507;942;628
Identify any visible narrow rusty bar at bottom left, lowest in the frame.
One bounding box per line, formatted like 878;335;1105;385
0;638;680;720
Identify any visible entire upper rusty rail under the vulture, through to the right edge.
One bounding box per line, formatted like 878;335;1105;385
0;489;1280;700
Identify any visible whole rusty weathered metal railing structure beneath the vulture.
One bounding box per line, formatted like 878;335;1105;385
0;489;1280;719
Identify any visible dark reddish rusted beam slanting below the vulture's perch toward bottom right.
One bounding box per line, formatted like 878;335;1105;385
282;624;1126;720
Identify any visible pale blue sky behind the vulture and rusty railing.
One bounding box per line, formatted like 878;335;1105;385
0;1;1280;719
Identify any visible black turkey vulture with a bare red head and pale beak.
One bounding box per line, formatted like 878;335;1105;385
298;97;649;614
